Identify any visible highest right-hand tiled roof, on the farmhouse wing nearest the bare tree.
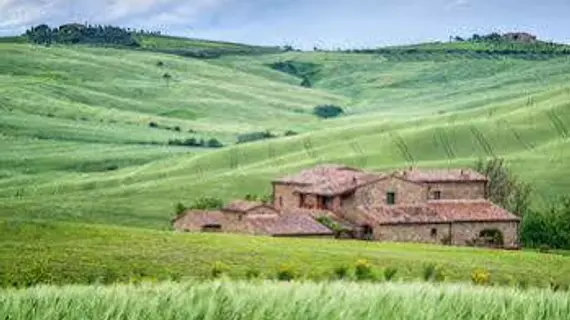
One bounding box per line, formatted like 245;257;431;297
397;168;488;182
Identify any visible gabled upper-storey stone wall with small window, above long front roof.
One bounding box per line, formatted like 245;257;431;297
353;177;427;205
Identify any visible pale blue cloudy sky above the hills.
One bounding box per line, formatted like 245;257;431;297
0;0;570;49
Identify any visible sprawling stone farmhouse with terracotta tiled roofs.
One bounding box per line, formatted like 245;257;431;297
172;164;520;248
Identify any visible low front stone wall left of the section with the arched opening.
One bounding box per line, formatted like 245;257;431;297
374;223;450;244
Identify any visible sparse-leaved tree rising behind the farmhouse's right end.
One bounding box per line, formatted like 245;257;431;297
475;158;532;216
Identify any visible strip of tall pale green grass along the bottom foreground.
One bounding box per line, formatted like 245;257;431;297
4;281;570;320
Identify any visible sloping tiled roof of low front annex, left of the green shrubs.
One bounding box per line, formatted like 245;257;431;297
243;214;333;236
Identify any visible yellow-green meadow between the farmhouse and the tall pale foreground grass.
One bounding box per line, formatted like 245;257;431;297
0;221;570;287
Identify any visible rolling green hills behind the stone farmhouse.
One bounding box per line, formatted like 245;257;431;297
0;26;570;238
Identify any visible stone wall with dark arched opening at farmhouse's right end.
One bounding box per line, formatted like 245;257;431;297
451;221;519;247
